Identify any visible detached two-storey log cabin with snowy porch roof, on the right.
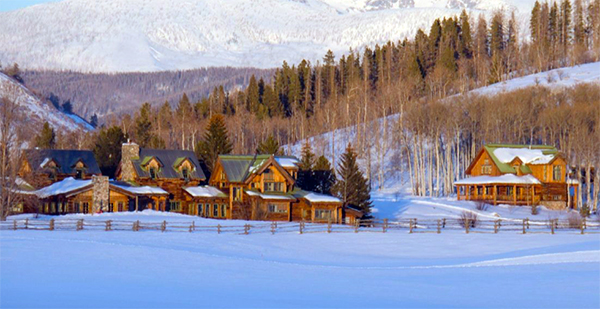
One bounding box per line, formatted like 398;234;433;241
454;144;578;209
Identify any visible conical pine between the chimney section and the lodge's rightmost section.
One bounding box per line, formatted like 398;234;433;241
196;114;233;172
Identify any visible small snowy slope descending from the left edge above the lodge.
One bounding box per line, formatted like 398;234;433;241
0;73;94;132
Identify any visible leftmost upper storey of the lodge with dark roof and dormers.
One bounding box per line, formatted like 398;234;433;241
18;149;102;189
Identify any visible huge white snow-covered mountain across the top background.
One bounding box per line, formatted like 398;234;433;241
0;0;534;72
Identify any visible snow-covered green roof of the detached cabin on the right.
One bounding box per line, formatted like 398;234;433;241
467;144;560;174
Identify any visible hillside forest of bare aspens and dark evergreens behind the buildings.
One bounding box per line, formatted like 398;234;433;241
3;0;600;212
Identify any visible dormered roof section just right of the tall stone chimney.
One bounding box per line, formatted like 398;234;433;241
131;148;206;180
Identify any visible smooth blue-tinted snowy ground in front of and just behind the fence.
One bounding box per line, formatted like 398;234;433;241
0;207;600;308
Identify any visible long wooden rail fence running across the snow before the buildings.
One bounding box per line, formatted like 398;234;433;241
0;218;600;235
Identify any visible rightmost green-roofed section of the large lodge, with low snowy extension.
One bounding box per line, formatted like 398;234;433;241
209;155;362;223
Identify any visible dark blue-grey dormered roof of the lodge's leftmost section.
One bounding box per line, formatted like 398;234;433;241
24;149;101;175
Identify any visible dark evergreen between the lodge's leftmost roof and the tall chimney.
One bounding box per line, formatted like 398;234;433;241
93;126;127;177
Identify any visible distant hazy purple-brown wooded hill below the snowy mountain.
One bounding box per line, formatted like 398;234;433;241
21;67;273;122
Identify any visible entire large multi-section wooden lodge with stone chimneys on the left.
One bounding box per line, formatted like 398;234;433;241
19;143;363;223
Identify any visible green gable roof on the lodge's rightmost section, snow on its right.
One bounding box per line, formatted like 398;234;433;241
218;155;300;183
